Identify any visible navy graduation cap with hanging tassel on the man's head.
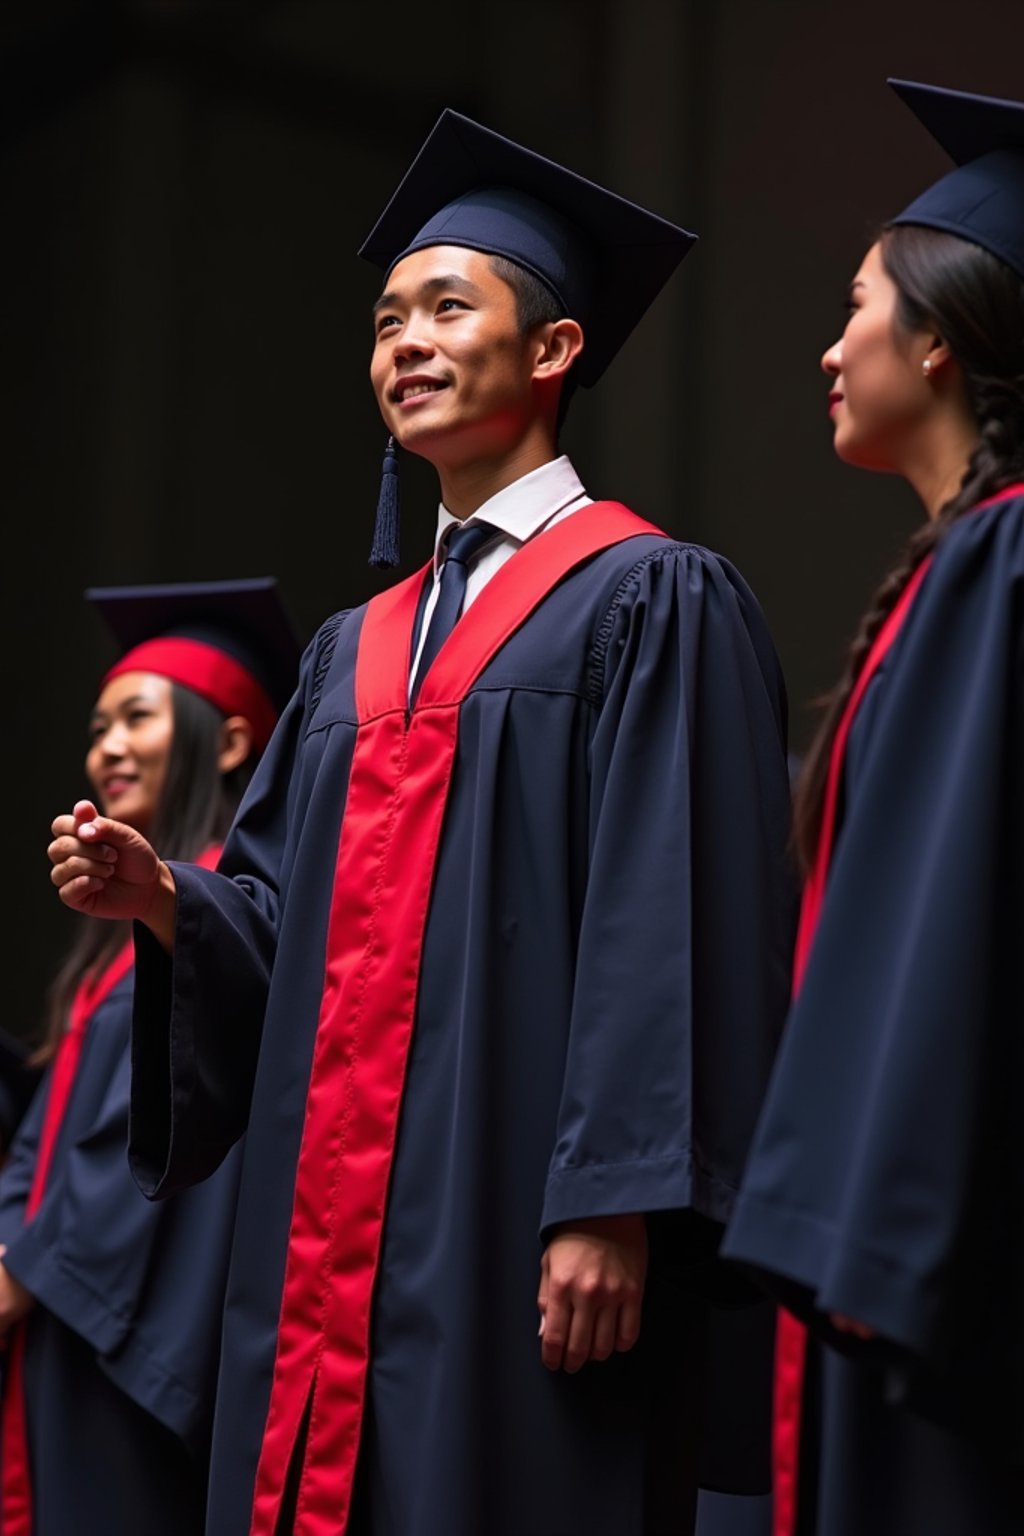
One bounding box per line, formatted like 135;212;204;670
359;109;697;565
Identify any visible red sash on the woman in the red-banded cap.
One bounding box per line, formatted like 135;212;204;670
0;846;221;1536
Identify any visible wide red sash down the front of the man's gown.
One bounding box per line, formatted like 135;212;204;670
252;502;662;1536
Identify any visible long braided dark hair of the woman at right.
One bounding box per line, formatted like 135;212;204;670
794;224;1024;871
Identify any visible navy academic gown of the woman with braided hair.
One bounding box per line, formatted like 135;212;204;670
723;487;1024;1536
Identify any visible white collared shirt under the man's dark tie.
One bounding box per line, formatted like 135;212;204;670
410;453;593;687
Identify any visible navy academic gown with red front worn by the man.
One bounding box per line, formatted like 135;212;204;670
132;507;794;1536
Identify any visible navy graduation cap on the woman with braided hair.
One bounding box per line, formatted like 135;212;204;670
887;80;1024;278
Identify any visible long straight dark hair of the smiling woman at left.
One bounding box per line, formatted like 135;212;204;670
32;682;256;1064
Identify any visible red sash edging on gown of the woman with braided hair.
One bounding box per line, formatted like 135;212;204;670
772;482;1024;1536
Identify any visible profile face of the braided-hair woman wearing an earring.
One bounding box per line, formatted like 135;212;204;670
821;244;933;473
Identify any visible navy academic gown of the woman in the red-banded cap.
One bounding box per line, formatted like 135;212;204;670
0;952;241;1536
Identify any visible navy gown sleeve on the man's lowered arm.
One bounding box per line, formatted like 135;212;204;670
542;544;795;1269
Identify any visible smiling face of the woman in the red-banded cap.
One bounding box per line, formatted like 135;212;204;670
86;671;173;833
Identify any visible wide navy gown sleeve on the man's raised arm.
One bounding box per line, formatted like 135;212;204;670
129;616;342;1200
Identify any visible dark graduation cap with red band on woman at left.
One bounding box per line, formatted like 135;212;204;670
86;576;301;751
